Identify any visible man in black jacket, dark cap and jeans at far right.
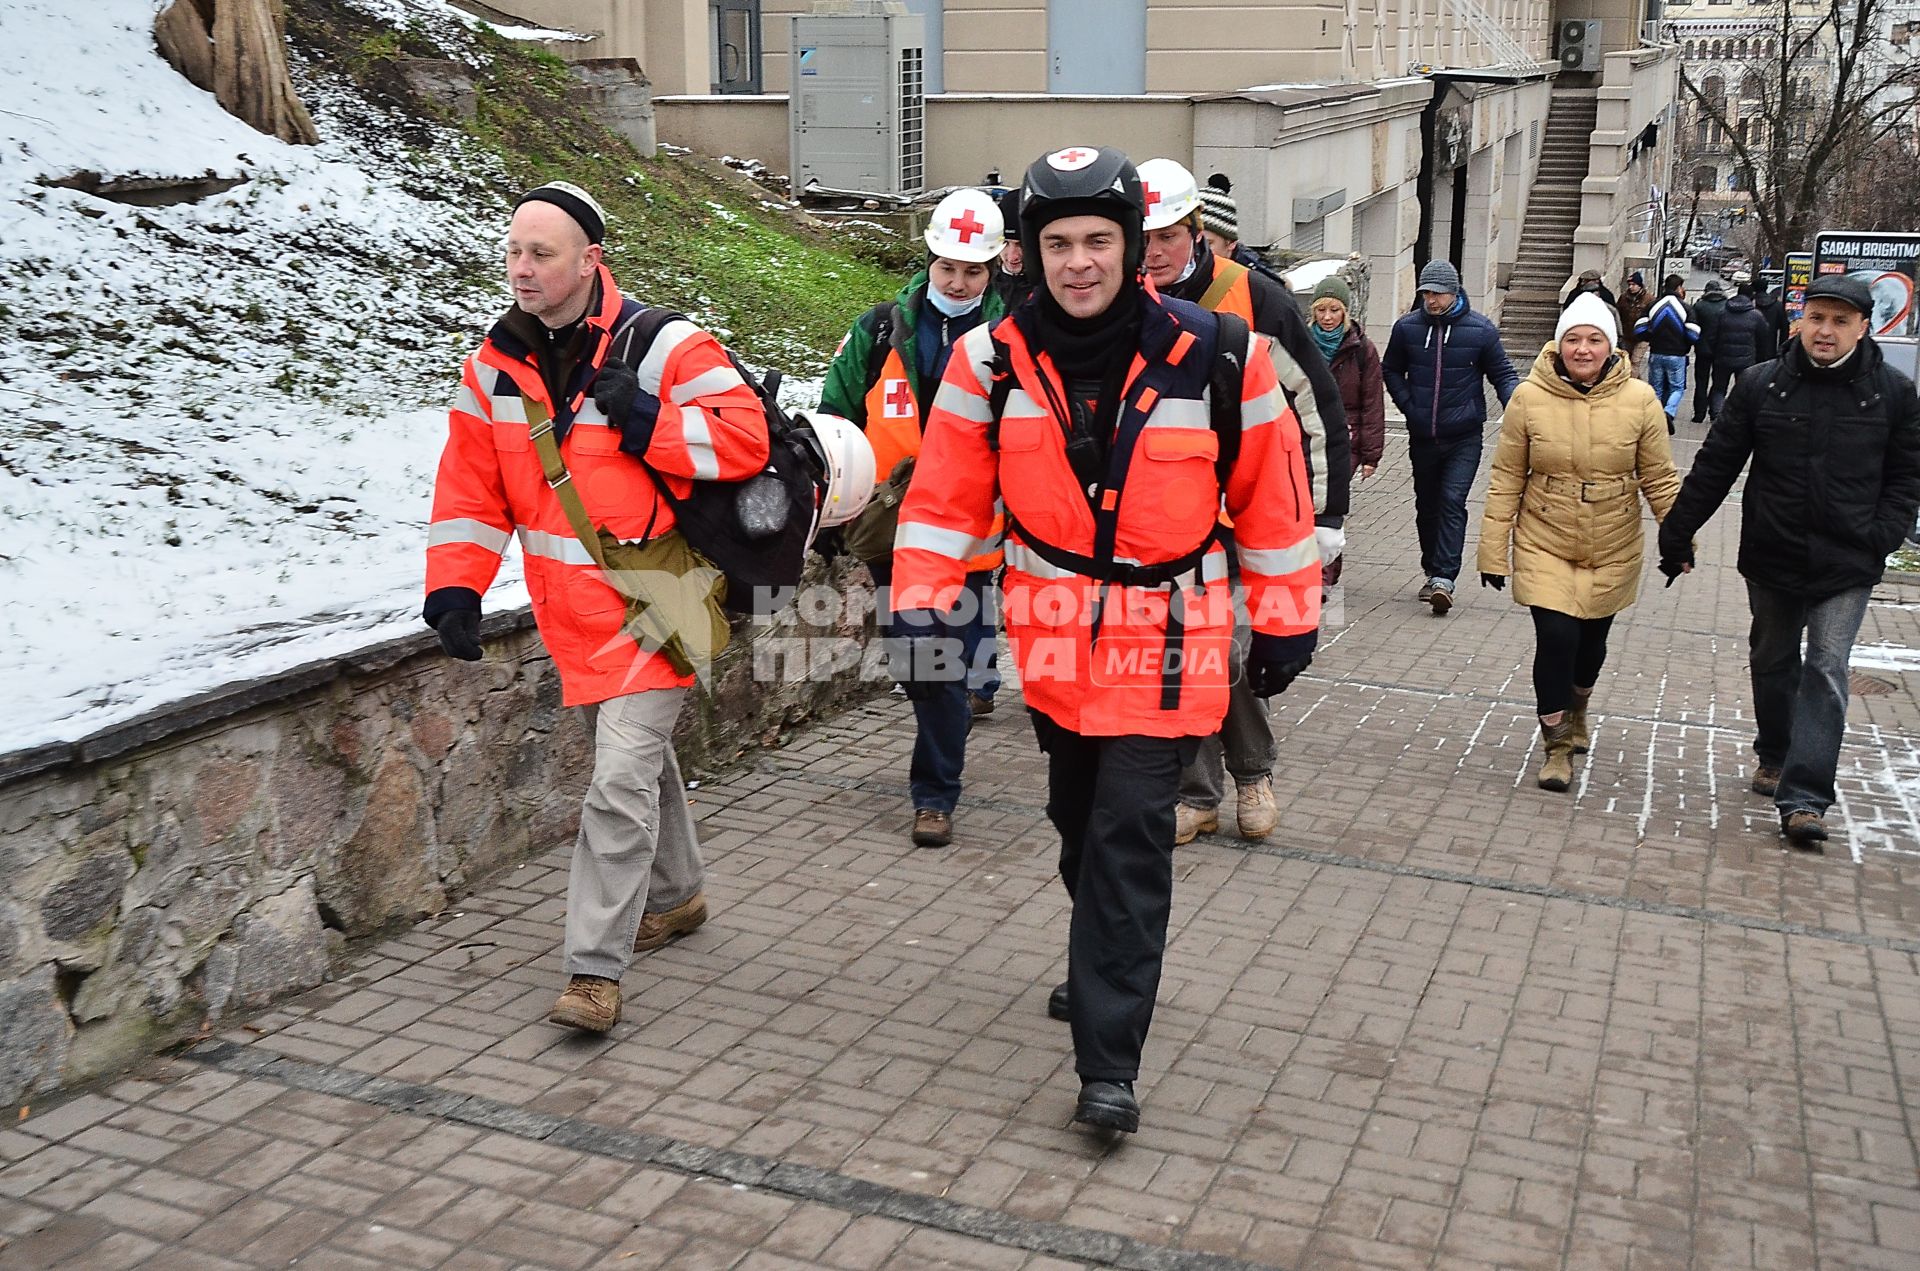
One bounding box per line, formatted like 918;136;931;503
1661;275;1920;851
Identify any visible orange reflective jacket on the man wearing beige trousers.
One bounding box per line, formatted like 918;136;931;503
426;265;768;707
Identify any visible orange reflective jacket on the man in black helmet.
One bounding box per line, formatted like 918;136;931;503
893;296;1321;737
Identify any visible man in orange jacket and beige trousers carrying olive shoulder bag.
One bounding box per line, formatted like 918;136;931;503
424;182;768;1033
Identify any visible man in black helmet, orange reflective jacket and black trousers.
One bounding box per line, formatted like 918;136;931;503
893;146;1321;1131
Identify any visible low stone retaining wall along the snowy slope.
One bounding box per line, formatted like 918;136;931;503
0;563;877;1102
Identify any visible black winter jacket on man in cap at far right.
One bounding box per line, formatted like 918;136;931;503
1661;338;1920;599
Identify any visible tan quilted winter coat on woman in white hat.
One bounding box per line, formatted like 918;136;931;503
1480;344;1680;618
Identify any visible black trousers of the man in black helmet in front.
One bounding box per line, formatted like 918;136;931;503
1033;710;1200;1081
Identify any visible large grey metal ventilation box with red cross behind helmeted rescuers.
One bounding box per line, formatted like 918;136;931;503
787;4;927;194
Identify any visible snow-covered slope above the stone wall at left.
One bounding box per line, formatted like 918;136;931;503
0;0;537;751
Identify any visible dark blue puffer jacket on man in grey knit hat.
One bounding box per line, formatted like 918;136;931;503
1380;296;1521;442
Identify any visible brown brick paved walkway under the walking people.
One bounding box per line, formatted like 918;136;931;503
0;418;1920;1271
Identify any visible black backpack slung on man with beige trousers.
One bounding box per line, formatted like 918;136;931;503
607;301;826;616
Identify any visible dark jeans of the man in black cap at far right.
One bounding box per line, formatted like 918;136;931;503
1747;580;1874;816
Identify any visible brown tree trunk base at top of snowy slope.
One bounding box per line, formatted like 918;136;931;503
154;0;321;146
